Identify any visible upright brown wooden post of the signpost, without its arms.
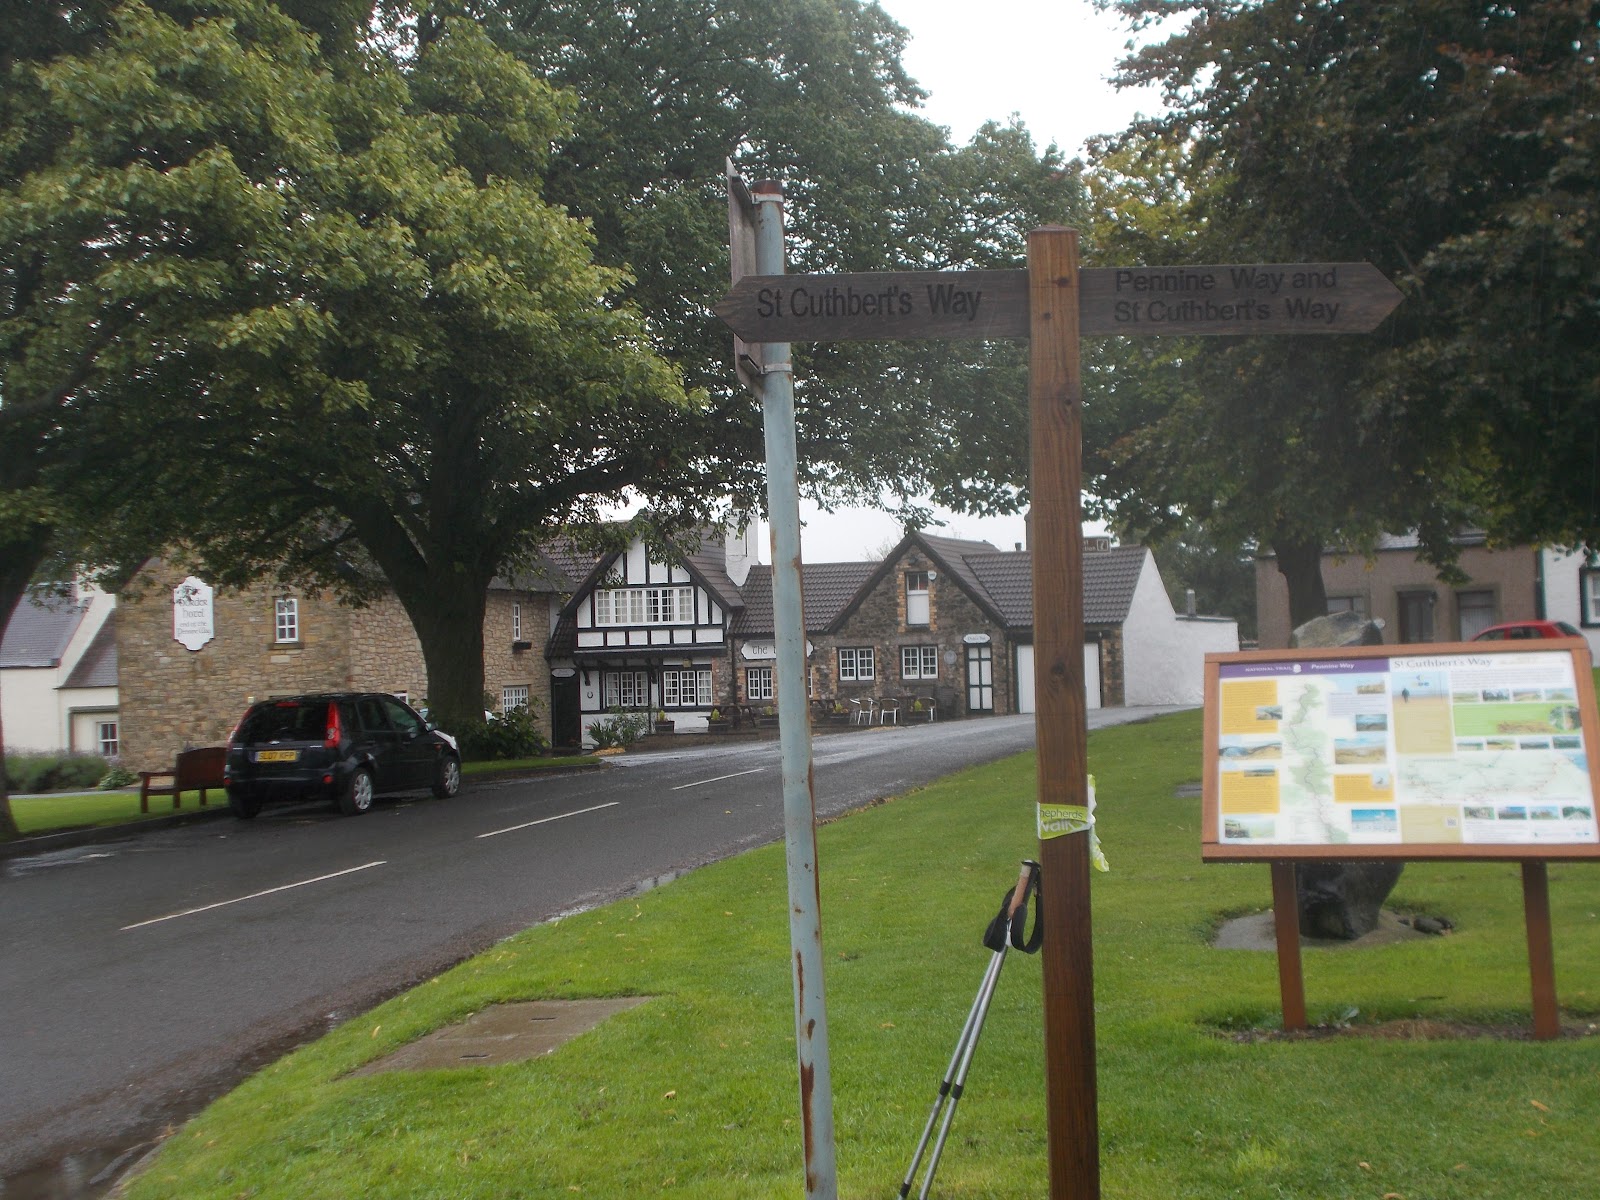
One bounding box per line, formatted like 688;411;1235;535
1027;227;1099;1200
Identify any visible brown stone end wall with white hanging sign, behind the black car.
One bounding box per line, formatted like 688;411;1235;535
117;562;352;771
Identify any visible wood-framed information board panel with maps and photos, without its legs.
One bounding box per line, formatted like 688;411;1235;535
1202;638;1600;861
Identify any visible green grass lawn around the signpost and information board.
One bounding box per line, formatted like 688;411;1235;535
128;712;1600;1200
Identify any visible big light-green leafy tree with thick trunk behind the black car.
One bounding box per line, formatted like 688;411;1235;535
0;0;690;752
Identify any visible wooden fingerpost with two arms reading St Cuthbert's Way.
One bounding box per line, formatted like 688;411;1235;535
717;204;1400;1200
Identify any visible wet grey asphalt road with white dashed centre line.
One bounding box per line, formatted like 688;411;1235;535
0;709;1177;1200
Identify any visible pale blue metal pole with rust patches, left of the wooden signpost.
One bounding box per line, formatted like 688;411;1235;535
750;179;838;1200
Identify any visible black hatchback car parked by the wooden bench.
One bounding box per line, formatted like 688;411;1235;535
222;691;461;821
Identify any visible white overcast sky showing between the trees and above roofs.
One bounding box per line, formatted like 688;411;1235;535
787;0;1158;563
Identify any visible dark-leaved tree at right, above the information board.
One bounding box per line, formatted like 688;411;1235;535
1098;0;1600;621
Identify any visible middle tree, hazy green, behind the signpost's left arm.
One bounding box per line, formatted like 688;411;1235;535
475;0;1080;521
